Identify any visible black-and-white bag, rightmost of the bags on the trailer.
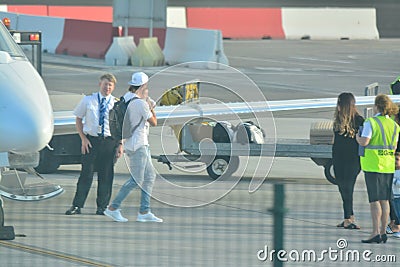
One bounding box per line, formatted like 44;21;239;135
235;121;265;145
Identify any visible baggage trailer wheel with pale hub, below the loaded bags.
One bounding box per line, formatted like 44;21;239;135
207;156;239;180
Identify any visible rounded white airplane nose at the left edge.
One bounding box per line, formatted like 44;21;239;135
0;62;53;153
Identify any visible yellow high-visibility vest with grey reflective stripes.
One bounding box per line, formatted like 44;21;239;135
360;116;399;173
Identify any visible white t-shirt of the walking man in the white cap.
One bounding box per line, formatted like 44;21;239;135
124;96;153;151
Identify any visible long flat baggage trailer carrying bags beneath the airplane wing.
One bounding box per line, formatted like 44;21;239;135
153;122;336;184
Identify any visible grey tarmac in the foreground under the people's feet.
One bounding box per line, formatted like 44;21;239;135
0;160;400;266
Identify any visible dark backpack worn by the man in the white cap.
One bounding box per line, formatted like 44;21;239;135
108;96;138;141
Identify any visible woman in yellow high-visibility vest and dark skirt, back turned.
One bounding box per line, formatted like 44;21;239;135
356;94;400;243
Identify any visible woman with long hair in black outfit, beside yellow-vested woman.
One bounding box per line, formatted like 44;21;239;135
332;93;364;229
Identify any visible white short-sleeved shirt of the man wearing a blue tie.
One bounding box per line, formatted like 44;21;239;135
74;92;115;136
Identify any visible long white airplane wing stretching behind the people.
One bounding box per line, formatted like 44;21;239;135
54;95;400;135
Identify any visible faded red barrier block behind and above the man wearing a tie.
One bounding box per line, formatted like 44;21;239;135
56;19;117;58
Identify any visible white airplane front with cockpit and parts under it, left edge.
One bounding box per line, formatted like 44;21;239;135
0;22;64;203
